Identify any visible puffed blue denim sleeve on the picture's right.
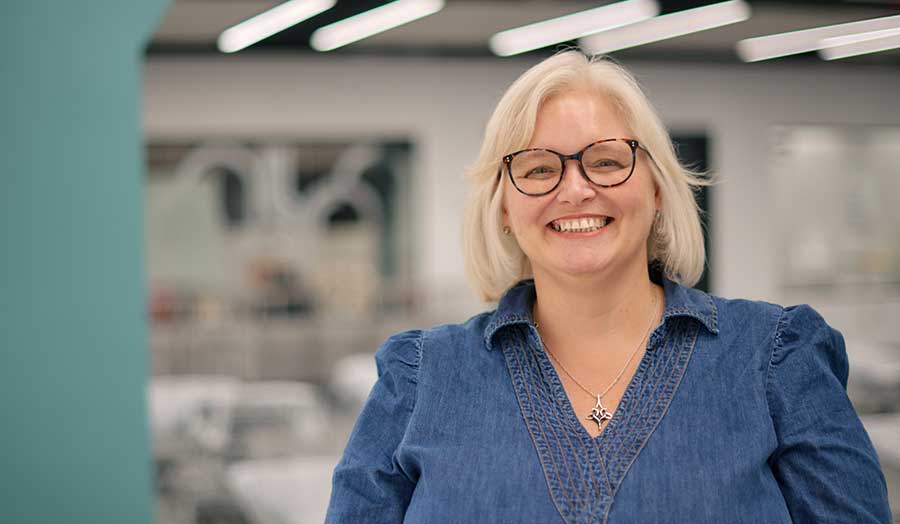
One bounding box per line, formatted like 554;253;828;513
767;305;891;524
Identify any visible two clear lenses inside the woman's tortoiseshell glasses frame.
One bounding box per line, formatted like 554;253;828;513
509;140;634;194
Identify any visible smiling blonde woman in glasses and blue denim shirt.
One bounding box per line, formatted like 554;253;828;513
327;51;891;524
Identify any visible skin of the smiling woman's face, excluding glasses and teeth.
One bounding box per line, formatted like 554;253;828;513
503;91;659;276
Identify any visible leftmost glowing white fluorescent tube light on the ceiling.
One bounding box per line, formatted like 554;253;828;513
216;0;335;53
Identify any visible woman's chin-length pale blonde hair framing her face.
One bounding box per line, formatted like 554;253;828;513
463;50;710;301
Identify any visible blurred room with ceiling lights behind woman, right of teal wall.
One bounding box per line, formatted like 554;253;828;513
0;0;900;524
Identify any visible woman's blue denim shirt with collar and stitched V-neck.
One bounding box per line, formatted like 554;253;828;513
326;277;891;524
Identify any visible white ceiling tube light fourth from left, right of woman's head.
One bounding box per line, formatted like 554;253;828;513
578;0;750;55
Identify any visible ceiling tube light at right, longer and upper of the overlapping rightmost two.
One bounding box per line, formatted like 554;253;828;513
737;15;900;62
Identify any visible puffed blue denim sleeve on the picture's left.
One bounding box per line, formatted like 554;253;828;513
325;331;422;524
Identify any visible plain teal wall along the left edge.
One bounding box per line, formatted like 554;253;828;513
0;0;166;524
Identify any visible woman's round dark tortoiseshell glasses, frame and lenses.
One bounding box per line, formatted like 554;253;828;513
503;138;653;196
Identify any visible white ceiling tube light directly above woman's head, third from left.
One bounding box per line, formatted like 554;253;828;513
488;0;659;56
